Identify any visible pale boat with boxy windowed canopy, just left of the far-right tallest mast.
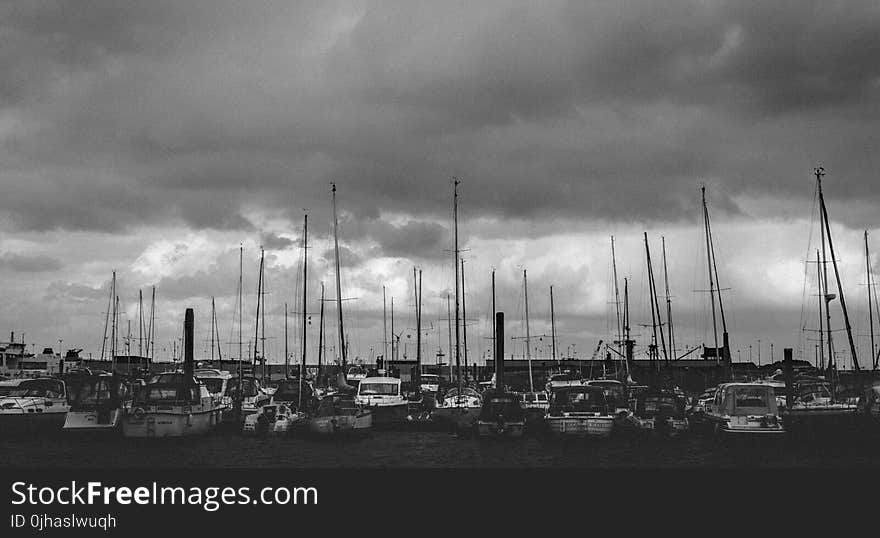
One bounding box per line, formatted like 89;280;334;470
706;382;785;439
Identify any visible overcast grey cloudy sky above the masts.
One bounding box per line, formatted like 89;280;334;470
0;0;880;364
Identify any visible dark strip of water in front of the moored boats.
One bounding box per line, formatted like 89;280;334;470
0;431;880;468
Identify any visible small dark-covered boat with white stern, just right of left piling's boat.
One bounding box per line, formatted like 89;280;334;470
242;378;316;435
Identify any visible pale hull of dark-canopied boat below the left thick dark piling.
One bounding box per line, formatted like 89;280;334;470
122;409;222;439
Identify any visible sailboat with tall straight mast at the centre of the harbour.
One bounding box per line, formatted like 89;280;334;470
432;178;483;431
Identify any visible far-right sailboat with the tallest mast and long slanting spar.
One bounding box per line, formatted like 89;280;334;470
782;167;867;439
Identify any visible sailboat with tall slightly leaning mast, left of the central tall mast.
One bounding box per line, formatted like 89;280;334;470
309;184;373;436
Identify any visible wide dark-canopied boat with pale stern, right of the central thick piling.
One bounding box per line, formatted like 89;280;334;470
544;385;614;439
